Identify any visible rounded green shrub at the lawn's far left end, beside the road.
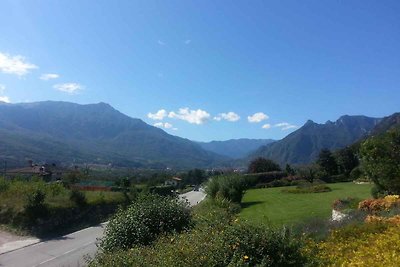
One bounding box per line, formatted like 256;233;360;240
206;175;247;203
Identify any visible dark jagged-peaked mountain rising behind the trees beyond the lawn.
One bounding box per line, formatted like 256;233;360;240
249;115;381;165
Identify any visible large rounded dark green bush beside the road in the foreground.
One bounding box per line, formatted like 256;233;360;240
100;195;191;251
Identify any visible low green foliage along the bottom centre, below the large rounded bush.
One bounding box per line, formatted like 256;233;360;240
90;202;309;267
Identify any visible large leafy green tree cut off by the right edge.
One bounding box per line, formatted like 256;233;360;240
361;129;400;194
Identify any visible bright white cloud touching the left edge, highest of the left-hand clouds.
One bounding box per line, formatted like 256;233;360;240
0;52;38;76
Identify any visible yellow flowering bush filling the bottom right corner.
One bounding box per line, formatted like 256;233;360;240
305;223;400;266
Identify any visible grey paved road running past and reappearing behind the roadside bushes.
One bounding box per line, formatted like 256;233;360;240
0;191;205;267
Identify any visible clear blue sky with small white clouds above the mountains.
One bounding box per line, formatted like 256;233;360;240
0;0;400;141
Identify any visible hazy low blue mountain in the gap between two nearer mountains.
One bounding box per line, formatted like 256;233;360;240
199;138;275;159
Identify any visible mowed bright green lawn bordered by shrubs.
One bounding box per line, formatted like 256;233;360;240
239;183;372;225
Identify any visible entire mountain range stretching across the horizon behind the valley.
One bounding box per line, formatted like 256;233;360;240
0;101;400;169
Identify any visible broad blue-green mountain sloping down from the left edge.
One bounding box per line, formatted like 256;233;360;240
0;101;225;168
